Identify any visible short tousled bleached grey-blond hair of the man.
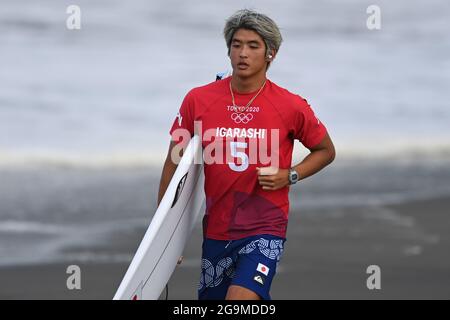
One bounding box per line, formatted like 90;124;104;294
223;9;283;67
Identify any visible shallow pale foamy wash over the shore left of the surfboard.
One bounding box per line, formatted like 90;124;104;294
0;218;148;267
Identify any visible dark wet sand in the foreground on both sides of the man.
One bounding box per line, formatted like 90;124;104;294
0;197;450;299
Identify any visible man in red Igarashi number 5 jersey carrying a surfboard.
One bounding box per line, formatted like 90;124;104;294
158;10;335;300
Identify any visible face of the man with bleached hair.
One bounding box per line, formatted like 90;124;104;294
230;29;267;78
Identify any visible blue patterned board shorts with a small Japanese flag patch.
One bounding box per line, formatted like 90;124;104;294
198;235;286;300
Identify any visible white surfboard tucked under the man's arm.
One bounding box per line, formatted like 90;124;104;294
114;135;205;300
